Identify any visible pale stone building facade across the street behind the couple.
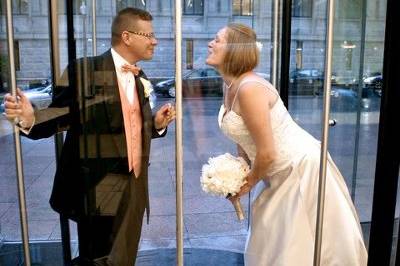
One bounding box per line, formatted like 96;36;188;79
0;0;386;87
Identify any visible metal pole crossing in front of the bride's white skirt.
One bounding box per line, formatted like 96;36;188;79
314;0;335;266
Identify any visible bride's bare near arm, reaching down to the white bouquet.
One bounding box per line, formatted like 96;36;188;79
233;82;277;196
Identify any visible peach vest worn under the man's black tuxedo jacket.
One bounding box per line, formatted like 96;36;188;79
118;79;142;178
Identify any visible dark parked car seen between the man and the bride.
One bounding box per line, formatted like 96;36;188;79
154;68;269;97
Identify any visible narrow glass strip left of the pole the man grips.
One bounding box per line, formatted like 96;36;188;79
0;1;23;260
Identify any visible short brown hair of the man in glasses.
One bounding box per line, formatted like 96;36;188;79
111;7;153;46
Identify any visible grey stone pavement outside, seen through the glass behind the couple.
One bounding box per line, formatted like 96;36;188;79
0;95;396;265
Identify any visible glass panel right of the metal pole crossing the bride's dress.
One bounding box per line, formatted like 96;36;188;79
330;0;386;244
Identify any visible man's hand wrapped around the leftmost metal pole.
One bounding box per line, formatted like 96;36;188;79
4;88;35;128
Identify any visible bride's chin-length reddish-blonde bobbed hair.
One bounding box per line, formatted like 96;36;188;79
221;23;260;77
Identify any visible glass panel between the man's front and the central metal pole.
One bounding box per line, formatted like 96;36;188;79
134;1;176;254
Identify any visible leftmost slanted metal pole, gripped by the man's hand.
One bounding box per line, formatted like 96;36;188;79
6;0;31;266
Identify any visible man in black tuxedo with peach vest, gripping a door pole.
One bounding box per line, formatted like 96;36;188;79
5;8;175;266
